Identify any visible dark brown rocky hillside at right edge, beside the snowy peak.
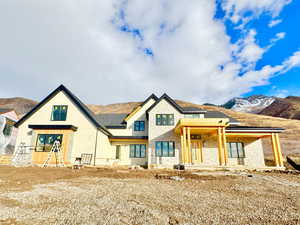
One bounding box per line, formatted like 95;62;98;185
259;96;300;120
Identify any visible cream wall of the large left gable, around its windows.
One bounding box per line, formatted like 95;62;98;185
16;92;103;163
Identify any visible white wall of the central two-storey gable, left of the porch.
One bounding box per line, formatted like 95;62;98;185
148;99;184;166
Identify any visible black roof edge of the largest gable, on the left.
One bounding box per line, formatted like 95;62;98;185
15;85;111;135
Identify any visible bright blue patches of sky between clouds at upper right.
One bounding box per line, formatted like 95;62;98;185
216;0;300;97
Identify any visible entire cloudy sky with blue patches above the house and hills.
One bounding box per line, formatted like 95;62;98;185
0;0;300;104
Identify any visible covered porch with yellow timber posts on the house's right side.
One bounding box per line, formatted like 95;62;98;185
175;118;284;169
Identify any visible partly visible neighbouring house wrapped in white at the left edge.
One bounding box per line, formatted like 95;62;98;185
0;108;18;155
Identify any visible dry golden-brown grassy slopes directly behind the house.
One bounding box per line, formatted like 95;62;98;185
0;97;300;157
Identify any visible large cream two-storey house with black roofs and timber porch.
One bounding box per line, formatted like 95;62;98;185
15;85;284;169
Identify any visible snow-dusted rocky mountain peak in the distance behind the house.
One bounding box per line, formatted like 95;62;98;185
222;95;276;113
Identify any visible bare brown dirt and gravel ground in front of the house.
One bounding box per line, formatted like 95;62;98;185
0;166;300;225
